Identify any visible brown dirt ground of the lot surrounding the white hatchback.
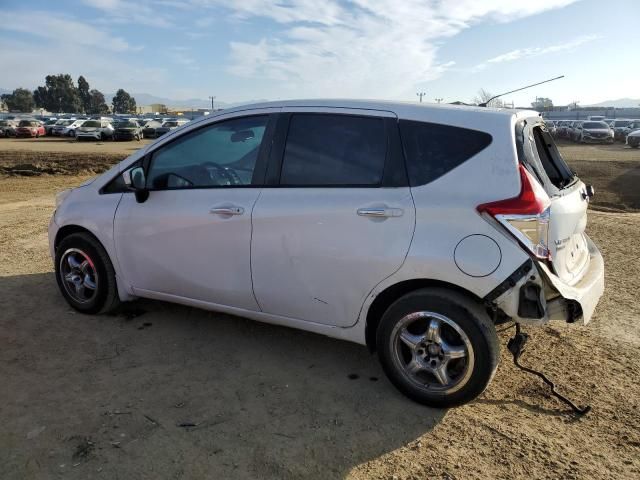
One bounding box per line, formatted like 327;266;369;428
0;137;640;479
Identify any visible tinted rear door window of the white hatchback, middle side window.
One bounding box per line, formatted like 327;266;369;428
280;113;387;186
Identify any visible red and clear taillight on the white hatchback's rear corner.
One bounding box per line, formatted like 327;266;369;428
477;165;551;260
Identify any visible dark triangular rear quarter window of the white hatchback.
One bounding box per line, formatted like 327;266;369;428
400;120;492;187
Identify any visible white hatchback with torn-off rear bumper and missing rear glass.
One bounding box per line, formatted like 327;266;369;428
49;100;604;407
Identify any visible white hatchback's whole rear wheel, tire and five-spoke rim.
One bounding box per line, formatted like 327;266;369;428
376;288;500;408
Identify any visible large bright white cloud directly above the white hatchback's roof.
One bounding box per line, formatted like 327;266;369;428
214;0;573;98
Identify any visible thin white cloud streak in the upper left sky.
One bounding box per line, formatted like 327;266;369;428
0;11;141;52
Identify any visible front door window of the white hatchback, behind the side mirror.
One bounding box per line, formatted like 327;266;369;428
147;115;268;189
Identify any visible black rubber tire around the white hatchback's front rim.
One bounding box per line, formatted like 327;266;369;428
55;232;120;314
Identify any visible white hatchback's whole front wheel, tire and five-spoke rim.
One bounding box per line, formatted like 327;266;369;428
55;233;120;314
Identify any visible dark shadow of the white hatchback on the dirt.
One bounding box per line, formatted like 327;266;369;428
0;274;445;478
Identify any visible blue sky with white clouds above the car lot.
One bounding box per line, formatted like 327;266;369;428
0;0;640;106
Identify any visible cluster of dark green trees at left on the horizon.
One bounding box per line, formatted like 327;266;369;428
1;74;136;115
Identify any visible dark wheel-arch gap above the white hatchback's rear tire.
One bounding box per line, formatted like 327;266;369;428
365;278;483;353
